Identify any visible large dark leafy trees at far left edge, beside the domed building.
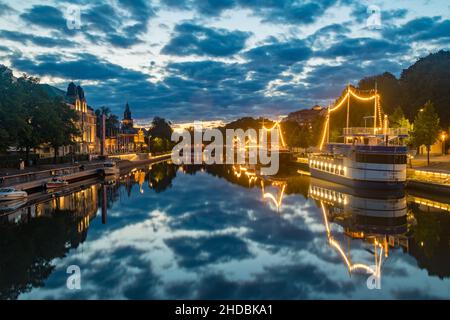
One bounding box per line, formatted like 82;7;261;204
0;66;79;158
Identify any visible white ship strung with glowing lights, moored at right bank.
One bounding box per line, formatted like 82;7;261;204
308;87;408;189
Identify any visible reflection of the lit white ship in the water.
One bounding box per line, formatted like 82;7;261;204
309;178;408;289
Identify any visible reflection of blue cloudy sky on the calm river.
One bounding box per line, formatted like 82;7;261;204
22;173;448;299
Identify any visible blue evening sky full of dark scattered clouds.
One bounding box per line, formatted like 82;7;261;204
0;0;450;122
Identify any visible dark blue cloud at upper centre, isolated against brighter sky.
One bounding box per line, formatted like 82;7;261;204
161;22;250;57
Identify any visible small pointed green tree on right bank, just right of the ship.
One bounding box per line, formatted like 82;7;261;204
413;101;440;165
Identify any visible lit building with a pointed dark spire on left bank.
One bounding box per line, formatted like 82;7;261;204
117;102;147;153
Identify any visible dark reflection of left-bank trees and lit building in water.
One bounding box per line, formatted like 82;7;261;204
0;185;98;299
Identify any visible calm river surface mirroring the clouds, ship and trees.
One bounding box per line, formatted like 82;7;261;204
0;163;450;299
